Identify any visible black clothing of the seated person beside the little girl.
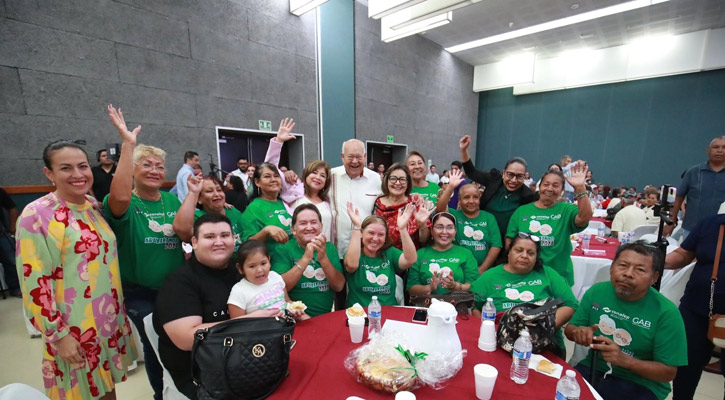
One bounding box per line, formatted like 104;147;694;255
153;256;242;394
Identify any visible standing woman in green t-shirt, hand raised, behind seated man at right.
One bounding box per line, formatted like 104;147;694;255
506;162;592;286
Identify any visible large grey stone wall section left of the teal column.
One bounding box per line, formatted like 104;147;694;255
0;0;318;186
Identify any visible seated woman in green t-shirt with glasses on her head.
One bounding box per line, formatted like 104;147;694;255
471;232;579;354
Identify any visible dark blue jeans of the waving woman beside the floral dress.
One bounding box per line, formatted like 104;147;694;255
123;282;164;400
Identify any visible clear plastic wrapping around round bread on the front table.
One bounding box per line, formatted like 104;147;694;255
345;331;467;393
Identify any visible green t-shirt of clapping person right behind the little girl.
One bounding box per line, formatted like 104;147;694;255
270;238;342;317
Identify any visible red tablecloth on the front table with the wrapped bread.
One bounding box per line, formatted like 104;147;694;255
270;306;594;400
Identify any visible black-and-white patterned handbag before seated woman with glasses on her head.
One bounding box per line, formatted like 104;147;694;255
496;299;562;353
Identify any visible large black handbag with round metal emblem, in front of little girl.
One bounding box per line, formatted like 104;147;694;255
191;316;295;400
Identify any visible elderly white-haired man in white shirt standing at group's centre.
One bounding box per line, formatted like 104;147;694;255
330;139;383;259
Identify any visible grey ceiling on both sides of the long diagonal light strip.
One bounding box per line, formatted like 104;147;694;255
412;0;725;65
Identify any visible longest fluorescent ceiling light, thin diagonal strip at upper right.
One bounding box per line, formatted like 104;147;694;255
446;0;669;53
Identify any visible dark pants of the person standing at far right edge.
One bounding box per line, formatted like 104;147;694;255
672;308;725;400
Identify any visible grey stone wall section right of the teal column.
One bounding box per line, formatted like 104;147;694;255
355;1;478;168
